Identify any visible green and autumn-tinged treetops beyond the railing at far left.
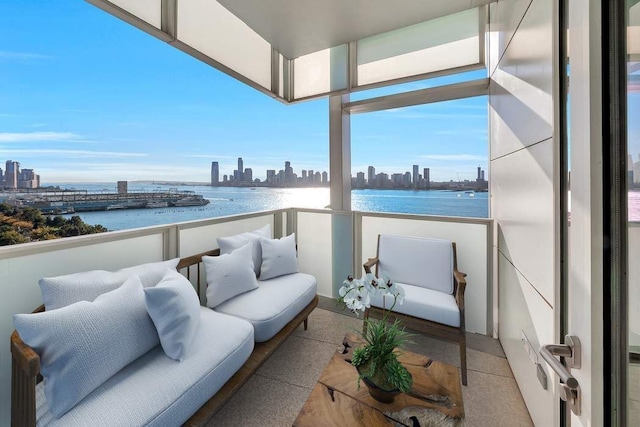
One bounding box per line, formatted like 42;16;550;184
0;204;108;246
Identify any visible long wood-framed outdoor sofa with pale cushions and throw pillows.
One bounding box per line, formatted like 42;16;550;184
11;229;318;426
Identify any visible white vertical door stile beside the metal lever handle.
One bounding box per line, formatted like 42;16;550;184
559;0;604;427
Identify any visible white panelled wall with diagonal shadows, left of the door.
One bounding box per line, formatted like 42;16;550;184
488;0;557;426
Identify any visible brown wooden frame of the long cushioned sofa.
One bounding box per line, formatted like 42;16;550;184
11;249;318;427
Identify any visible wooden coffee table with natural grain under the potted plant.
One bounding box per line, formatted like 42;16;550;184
293;334;464;427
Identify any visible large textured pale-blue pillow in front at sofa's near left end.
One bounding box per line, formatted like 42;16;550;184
13;276;159;418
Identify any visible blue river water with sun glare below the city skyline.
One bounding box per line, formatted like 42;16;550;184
37;183;489;230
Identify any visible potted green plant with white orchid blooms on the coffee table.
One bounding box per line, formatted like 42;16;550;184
339;274;413;403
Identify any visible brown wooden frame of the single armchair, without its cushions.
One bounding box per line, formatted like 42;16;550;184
363;236;467;385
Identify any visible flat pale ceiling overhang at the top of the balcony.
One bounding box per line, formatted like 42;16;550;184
218;0;495;59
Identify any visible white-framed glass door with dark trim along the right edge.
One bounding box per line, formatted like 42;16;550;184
559;0;640;427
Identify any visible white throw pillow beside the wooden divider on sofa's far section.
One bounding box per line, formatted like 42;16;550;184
202;243;258;308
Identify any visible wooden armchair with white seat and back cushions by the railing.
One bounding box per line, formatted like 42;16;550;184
364;234;467;385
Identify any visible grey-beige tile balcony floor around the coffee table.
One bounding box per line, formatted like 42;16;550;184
209;301;533;427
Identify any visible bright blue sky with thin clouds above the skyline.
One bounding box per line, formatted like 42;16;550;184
0;0;488;183
